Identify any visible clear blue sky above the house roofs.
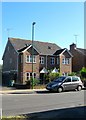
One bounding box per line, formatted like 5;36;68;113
0;2;84;64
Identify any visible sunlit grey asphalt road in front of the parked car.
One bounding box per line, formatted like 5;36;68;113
2;90;86;116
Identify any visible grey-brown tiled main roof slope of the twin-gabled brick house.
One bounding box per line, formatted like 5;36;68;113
9;38;61;55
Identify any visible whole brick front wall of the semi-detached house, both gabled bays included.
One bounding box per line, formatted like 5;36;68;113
20;51;72;83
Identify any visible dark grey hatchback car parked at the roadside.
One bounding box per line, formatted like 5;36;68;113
46;76;83;92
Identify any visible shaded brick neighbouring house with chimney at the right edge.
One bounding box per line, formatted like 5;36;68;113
70;43;86;72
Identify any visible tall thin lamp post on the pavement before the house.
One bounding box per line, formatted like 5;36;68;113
32;22;36;89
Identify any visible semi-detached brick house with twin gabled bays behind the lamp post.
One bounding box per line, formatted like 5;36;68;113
2;38;72;84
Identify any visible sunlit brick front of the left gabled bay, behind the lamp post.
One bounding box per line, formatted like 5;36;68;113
19;50;39;83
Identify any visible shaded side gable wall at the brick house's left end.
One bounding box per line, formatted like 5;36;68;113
3;40;18;72
